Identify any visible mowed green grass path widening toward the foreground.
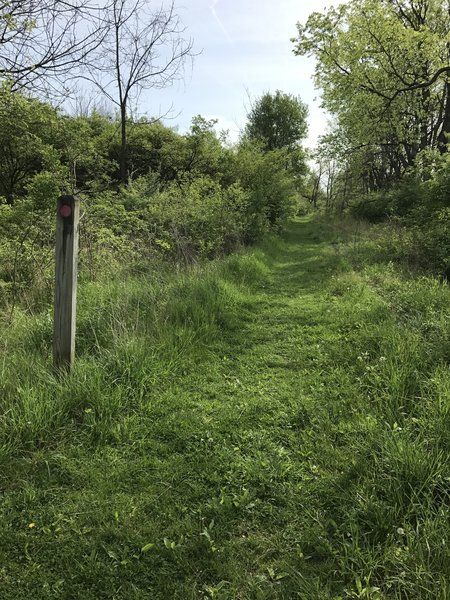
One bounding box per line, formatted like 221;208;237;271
4;219;446;600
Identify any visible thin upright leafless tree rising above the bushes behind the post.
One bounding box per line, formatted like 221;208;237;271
80;0;193;183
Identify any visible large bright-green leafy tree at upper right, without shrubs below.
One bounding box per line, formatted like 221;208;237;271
293;0;450;191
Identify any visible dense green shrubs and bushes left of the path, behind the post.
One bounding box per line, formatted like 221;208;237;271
0;85;306;309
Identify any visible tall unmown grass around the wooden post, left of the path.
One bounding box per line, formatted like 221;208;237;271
0;255;265;459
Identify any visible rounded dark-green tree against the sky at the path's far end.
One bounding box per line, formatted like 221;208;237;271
244;90;308;150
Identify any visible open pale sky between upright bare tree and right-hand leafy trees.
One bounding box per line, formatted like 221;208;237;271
141;0;338;148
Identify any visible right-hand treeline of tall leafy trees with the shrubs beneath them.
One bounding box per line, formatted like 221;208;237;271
293;0;450;276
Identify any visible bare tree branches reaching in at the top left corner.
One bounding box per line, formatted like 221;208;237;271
0;0;107;93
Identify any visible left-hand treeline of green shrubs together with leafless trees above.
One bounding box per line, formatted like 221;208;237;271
0;0;306;310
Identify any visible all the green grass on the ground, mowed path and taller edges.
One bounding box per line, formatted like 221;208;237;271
0;219;450;600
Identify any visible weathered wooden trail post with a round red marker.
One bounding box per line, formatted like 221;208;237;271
53;196;80;371
